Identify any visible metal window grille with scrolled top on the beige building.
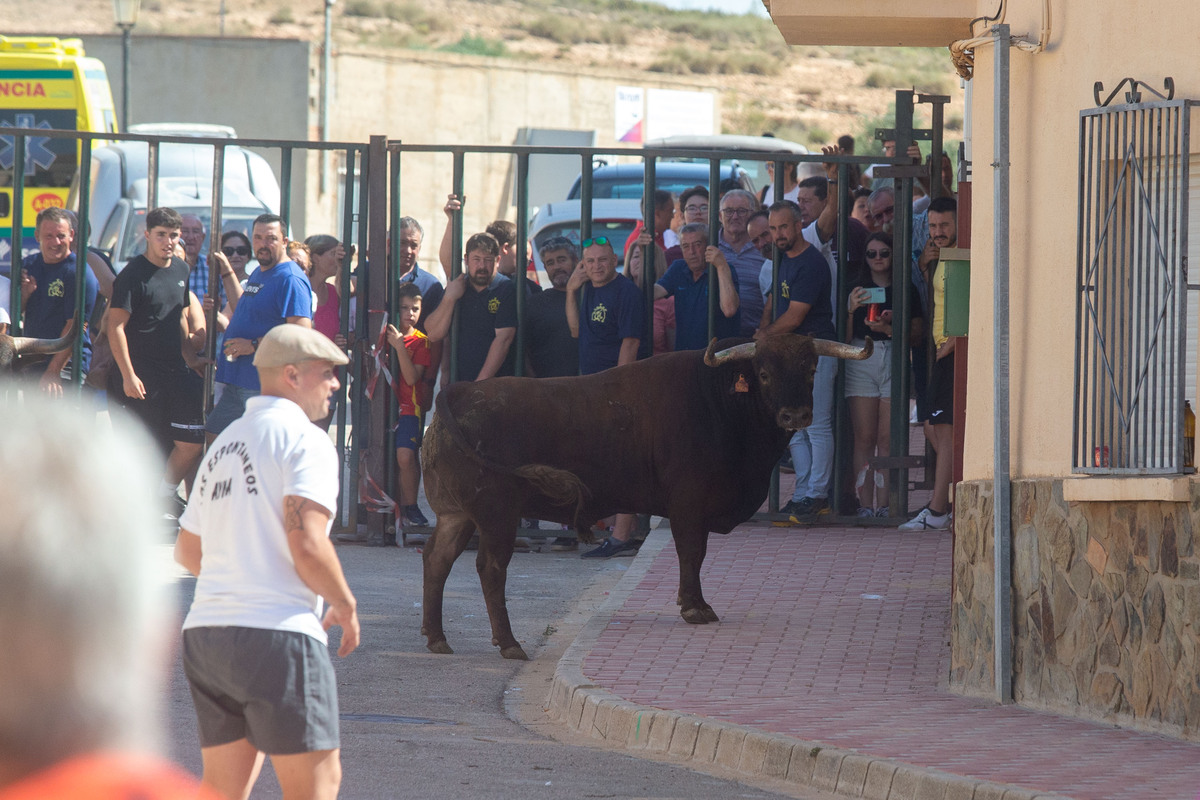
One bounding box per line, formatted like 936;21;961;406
1072;78;1194;475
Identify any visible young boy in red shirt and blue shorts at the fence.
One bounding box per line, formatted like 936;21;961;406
388;282;430;527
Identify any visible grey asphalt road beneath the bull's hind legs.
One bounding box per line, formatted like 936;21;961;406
163;532;827;800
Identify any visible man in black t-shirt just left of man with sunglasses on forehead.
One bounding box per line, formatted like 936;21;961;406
524;236;580;378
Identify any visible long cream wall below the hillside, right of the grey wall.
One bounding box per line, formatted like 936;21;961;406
319;50;721;278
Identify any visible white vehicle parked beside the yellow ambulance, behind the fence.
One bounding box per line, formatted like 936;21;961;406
72;142;280;271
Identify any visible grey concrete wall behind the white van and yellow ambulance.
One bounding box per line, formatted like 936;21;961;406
82;30;316;233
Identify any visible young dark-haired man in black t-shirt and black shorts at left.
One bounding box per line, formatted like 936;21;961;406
106;207;204;516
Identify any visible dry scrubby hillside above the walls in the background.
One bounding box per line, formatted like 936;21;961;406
7;0;962;150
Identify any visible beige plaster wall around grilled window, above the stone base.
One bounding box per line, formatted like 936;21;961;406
964;0;1200;481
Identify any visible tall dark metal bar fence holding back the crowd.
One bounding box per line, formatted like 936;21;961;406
5;123;936;528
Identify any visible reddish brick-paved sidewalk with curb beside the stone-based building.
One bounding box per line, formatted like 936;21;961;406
564;525;1200;800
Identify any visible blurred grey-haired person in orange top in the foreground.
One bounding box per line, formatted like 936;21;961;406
0;395;216;800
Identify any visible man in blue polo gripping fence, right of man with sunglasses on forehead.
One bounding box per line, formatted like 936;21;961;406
654;222;742;350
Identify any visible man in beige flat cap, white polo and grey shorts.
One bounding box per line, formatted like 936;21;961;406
175;325;359;799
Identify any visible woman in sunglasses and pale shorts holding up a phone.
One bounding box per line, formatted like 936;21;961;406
846;233;923;517
